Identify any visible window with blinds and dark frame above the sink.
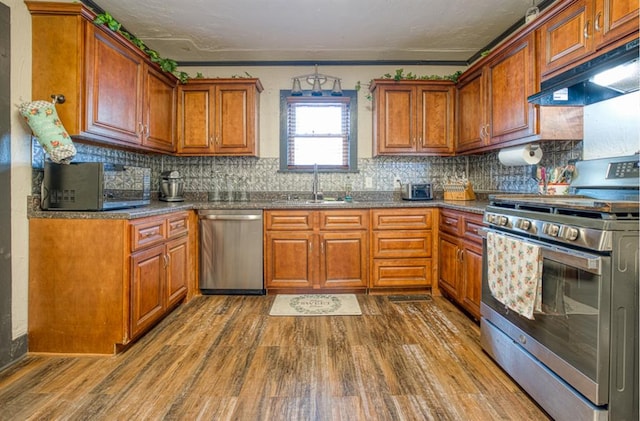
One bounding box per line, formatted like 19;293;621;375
280;91;357;172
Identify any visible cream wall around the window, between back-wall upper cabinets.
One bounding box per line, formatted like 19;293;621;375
180;66;463;158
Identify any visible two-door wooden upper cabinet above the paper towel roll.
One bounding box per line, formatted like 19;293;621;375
456;33;539;152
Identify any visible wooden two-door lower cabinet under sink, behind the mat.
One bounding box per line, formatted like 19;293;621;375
264;210;369;292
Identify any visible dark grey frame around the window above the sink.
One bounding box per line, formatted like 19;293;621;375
279;90;358;173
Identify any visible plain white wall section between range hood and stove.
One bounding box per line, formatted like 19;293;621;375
583;92;640;159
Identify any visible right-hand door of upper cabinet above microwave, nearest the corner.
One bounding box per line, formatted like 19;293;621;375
142;66;176;152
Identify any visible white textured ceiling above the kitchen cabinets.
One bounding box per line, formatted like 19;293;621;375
85;0;548;63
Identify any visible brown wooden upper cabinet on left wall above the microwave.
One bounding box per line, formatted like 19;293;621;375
25;2;178;152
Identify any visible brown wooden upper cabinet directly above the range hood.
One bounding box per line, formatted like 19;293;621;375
539;0;639;80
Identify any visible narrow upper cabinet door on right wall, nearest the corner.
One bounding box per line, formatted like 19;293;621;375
456;71;485;152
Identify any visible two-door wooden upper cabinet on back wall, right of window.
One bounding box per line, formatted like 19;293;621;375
371;79;455;155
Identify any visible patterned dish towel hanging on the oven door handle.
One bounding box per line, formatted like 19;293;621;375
487;232;542;320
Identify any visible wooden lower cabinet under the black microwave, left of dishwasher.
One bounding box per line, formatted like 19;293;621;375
29;212;195;354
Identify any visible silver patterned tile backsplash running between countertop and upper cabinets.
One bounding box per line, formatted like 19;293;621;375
32;141;582;197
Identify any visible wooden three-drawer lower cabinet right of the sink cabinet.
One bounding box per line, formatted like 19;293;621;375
369;208;437;293
